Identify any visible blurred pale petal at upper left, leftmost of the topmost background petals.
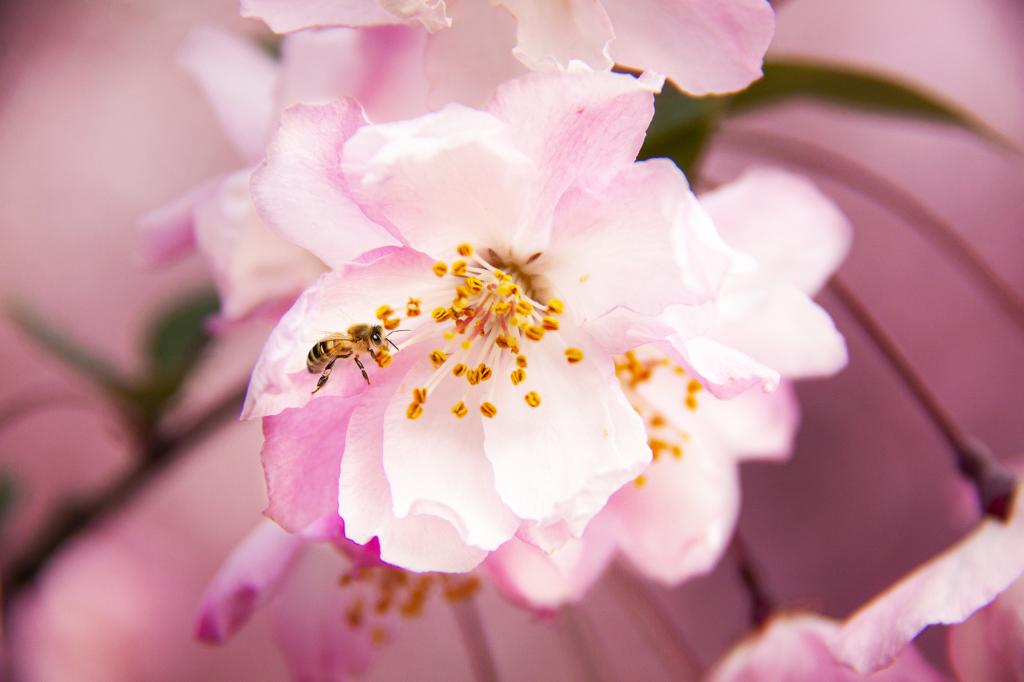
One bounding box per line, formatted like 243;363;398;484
178;26;278;162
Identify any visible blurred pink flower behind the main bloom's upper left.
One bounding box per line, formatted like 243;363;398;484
141;27;426;319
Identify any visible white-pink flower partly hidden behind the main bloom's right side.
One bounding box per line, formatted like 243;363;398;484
486;169;850;608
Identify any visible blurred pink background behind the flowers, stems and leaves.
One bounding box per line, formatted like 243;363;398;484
0;0;1024;680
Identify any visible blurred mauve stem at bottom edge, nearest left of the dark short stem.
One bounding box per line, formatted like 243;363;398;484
608;562;701;682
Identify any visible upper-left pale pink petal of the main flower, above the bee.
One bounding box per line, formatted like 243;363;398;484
252;98;397;268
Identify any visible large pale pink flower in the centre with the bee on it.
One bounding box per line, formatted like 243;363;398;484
239;74;745;570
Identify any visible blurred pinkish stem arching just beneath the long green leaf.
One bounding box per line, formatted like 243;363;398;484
715;128;1024;331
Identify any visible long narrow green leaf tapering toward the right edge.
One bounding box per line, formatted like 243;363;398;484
728;59;1015;148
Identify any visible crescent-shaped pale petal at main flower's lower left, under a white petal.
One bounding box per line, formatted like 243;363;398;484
338;345;486;571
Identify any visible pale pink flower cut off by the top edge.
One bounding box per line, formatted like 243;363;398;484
242;0;774;99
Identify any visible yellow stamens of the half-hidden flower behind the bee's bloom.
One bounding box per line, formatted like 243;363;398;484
615;350;703;487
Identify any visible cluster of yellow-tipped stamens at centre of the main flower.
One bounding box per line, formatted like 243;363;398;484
376;238;584;420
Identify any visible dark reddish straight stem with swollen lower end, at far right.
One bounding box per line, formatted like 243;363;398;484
828;276;1015;520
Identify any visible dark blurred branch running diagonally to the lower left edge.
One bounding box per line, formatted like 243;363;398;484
2;388;245;593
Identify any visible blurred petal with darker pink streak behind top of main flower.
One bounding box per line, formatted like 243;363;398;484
281;26;427;121
